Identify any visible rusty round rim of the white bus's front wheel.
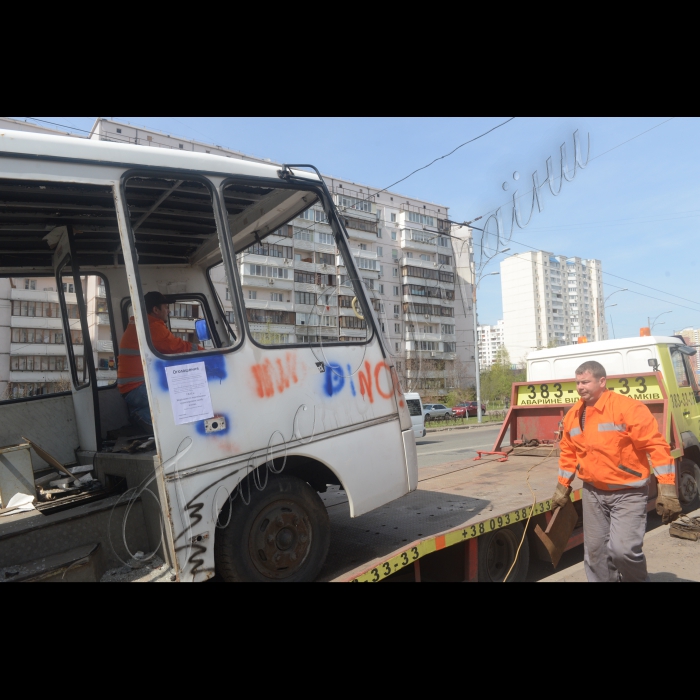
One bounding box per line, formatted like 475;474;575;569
249;500;312;579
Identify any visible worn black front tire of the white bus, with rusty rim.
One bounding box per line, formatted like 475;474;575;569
214;474;330;583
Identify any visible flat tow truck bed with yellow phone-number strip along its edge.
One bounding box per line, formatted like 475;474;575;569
320;452;582;582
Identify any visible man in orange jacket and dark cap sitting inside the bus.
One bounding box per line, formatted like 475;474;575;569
117;292;204;433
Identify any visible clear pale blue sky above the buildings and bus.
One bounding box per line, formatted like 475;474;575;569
17;115;700;338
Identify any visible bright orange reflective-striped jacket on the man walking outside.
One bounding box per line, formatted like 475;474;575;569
559;391;676;491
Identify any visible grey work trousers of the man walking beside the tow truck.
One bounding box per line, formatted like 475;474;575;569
583;483;649;583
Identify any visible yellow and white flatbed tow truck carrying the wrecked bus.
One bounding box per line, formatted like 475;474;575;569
318;329;700;582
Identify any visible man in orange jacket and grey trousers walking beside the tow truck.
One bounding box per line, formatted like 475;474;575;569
552;361;681;582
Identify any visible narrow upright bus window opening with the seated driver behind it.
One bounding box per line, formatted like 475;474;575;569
124;175;236;355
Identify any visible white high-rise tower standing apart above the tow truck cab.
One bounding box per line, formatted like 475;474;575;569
501;251;608;364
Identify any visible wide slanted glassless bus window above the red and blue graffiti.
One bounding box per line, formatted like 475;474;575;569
223;183;372;346
